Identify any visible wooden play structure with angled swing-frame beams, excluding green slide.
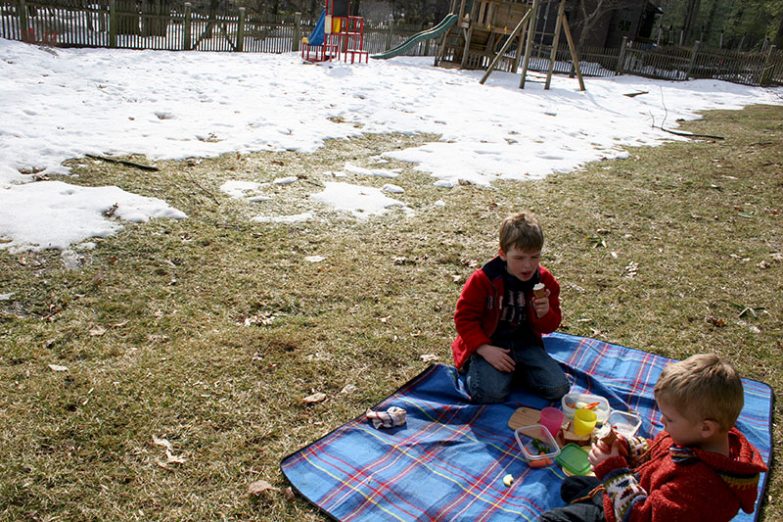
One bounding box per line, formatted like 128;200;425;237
435;0;585;91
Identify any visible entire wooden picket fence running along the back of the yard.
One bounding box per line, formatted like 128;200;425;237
0;0;783;85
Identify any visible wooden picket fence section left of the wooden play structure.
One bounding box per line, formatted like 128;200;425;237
0;0;437;55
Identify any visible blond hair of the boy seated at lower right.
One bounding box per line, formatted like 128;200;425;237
655;353;745;431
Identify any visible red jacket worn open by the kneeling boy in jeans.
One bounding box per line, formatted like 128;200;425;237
451;257;562;368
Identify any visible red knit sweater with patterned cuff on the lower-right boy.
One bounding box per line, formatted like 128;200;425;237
594;428;767;522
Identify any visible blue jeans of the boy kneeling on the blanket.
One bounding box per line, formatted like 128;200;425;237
465;342;570;403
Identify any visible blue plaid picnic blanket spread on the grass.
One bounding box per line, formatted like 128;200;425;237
281;333;772;522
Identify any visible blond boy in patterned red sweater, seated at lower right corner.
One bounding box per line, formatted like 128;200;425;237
540;354;767;522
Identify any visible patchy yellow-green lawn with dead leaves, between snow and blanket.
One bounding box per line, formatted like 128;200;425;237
0;106;783;521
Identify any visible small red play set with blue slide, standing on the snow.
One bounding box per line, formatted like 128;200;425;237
302;0;369;63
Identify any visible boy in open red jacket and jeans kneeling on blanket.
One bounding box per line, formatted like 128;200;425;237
451;212;569;403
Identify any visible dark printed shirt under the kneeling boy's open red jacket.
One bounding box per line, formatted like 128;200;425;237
492;273;535;346
